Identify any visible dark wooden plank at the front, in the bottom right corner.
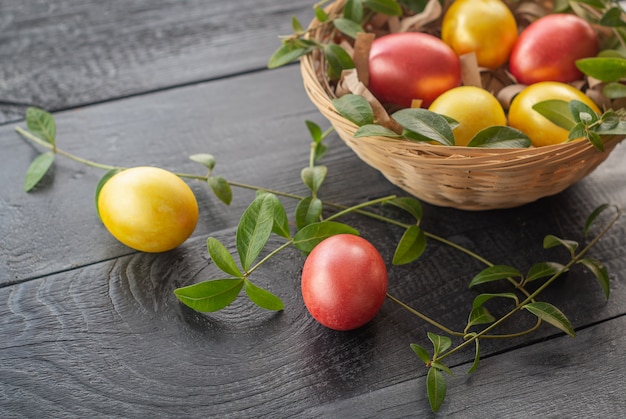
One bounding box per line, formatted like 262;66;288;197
304;316;626;418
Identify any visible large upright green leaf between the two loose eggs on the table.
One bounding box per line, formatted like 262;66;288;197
236;194;274;272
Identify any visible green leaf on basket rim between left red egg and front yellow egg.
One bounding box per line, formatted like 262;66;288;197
392;108;454;145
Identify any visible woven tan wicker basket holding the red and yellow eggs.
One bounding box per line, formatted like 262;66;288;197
301;0;622;210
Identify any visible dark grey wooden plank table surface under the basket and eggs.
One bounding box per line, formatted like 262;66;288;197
0;0;626;418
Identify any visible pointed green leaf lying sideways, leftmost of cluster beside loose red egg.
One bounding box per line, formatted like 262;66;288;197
174;278;244;312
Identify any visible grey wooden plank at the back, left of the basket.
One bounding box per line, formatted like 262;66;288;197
0;0;313;123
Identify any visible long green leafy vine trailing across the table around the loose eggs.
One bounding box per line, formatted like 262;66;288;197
16;108;623;411
